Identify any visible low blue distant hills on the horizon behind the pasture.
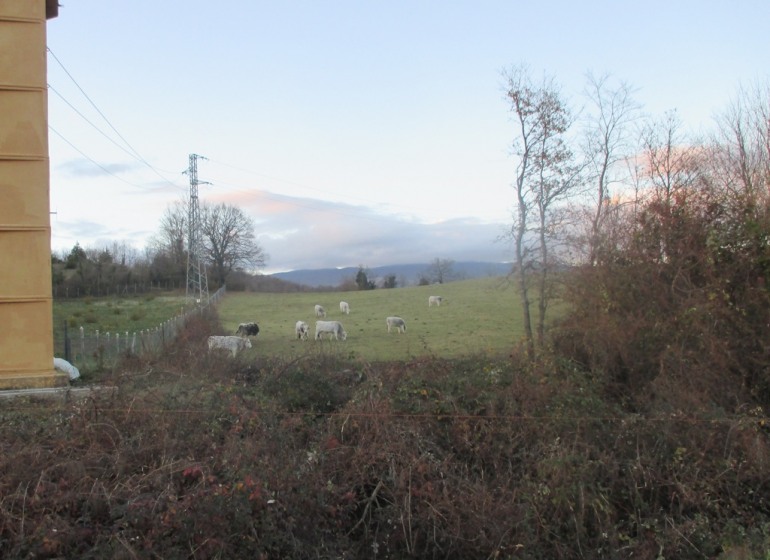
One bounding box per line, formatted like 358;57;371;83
269;261;511;288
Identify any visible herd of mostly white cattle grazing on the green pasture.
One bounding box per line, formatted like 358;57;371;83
208;296;444;357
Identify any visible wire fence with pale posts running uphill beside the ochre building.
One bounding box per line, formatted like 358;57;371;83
54;286;225;369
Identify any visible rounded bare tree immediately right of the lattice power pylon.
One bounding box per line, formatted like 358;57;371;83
201;204;267;285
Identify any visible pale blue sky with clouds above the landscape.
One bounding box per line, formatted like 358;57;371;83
47;0;770;273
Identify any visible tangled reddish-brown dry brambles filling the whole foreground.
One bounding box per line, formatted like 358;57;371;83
0;310;770;559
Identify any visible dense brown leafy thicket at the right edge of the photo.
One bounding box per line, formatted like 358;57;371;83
555;160;770;410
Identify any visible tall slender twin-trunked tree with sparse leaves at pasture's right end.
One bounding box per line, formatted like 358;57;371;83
506;66;578;354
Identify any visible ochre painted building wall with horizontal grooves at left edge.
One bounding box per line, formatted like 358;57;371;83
0;0;68;389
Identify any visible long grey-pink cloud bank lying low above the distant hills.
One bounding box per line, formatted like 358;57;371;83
210;191;511;272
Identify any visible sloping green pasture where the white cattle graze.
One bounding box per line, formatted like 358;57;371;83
216;278;523;361
